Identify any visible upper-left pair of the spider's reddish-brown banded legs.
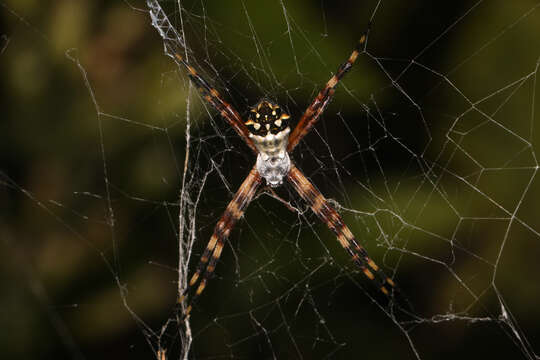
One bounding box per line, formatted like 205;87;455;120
174;53;257;152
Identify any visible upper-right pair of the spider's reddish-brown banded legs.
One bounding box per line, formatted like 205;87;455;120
287;31;367;152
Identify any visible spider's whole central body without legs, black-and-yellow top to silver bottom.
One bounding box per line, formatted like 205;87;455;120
245;100;291;187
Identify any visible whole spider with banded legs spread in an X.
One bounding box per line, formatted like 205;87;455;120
174;31;397;316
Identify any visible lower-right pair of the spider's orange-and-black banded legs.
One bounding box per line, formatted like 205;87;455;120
287;165;396;295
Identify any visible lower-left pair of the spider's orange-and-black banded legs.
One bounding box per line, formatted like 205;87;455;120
178;168;262;316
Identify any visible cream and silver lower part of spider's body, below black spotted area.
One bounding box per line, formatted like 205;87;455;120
250;127;291;187
